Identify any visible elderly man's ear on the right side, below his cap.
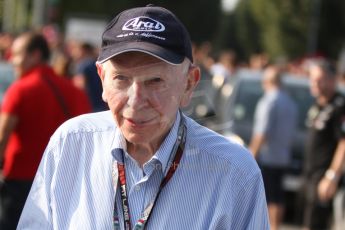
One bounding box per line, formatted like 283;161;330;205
180;65;200;107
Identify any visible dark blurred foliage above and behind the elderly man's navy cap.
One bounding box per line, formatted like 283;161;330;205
60;0;220;42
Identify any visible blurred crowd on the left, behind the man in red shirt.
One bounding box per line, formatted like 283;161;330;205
0;25;107;111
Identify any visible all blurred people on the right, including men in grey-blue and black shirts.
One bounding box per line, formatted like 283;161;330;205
194;42;345;230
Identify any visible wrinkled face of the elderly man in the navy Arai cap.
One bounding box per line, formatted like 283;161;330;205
99;52;194;148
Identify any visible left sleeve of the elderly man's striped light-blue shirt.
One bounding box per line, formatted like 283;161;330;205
17;140;56;230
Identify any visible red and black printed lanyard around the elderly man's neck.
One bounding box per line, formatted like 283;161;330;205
113;116;186;230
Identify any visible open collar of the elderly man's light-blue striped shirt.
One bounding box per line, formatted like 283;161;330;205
111;111;181;170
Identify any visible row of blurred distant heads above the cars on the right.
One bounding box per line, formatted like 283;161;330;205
193;42;345;84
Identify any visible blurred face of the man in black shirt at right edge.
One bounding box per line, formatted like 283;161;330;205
309;66;335;98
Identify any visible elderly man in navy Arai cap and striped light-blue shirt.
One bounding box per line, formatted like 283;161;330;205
18;5;269;229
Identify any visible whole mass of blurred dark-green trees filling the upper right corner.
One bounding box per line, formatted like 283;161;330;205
223;0;345;62
